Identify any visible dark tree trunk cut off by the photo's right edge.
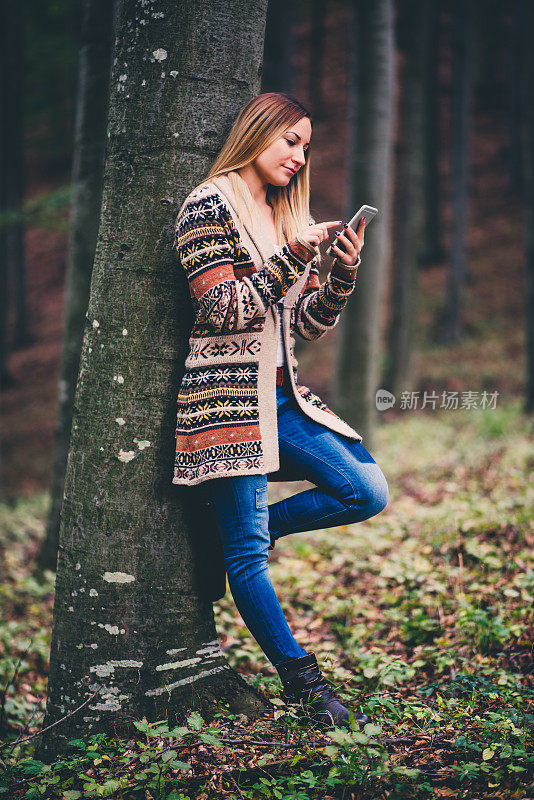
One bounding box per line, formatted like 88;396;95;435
522;2;534;414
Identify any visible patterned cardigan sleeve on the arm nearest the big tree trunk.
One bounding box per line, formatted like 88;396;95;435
174;198;317;332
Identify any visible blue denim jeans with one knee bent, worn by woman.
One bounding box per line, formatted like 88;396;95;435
203;386;388;665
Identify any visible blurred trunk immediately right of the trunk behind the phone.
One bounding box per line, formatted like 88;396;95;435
383;0;433;394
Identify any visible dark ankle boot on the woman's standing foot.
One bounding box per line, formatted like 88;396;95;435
274;653;369;728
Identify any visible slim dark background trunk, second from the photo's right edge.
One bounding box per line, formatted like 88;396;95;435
437;0;474;343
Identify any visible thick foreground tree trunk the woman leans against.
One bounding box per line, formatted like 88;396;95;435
40;0;266;755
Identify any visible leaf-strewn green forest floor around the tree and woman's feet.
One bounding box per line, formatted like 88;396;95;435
0;401;534;800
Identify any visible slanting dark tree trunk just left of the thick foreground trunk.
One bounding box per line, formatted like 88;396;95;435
37;0;118;570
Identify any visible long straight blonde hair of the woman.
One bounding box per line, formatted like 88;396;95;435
179;92;320;260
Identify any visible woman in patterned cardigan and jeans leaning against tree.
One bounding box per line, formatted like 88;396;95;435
173;93;388;725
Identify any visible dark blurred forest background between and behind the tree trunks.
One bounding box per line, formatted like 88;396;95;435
0;0;531;500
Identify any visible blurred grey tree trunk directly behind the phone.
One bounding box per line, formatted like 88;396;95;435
334;0;394;448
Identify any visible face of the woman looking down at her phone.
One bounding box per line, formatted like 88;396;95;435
252;117;312;186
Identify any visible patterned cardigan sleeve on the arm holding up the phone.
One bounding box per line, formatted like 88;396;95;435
295;217;356;341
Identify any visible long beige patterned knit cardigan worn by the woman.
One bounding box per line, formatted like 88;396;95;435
172;173;362;485
